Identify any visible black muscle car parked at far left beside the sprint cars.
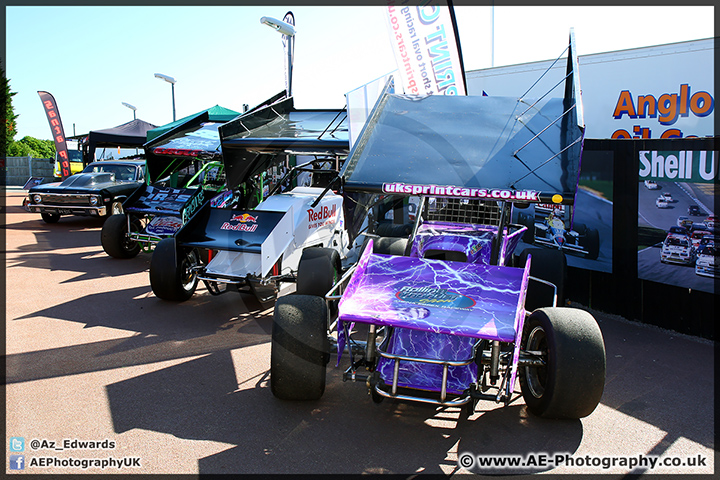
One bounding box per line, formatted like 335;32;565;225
27;160;145;223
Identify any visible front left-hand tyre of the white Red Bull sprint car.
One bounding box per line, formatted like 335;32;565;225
150;238;200;302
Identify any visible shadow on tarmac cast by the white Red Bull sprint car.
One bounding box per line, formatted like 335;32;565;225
6;287;272;383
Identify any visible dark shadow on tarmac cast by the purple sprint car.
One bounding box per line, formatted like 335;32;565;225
102;352;583;474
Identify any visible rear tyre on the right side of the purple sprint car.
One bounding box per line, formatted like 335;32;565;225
519;248;567;312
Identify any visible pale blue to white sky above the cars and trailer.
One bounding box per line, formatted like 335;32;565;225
6;6;715;140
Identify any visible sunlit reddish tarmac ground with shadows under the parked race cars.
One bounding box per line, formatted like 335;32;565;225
5;190;715;477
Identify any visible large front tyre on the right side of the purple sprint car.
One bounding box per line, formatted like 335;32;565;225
518;308;605;419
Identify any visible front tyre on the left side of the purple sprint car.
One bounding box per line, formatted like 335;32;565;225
270;295;330;400
